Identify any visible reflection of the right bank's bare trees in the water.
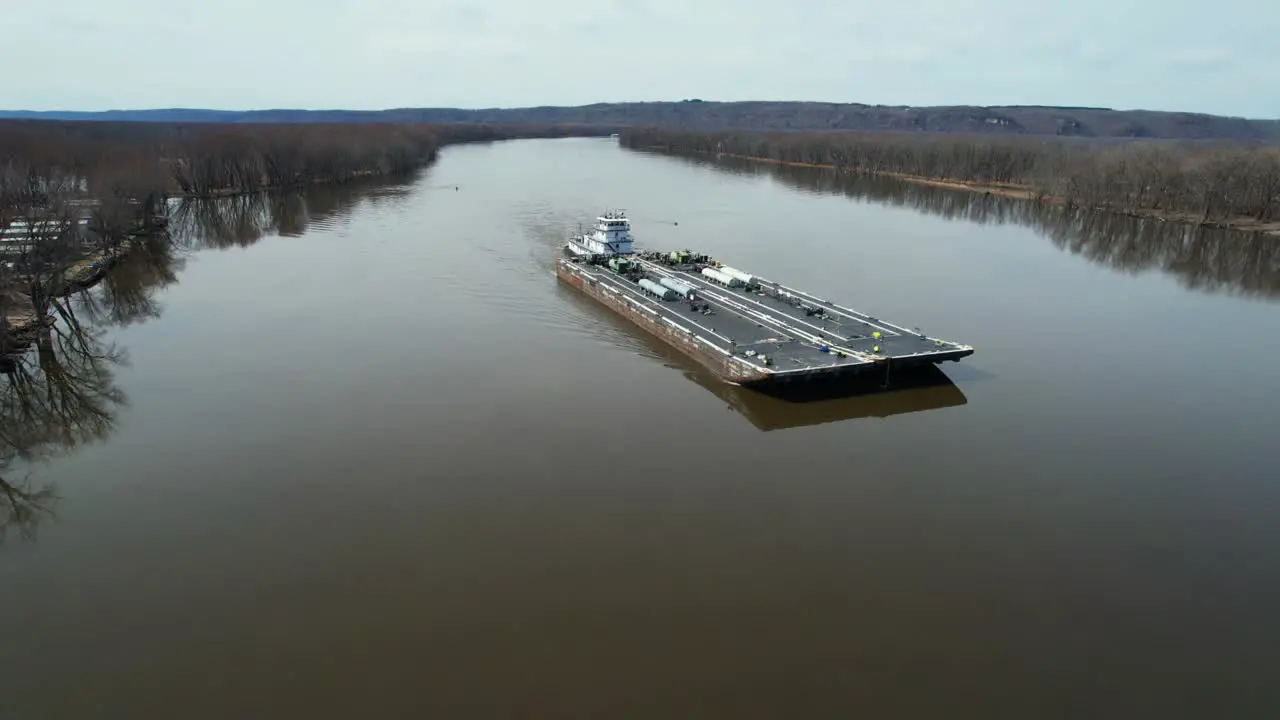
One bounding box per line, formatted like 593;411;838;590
650;149;1280;299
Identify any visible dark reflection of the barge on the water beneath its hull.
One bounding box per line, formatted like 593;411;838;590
564;278;968;432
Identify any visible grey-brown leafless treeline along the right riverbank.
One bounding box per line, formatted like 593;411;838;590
620;128;1280;224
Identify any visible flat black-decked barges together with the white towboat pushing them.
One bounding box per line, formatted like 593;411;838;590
556;211;973;387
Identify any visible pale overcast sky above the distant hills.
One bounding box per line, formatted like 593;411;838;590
0;0;1280;118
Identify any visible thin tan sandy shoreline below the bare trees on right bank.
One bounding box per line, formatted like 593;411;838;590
648;145;1280;237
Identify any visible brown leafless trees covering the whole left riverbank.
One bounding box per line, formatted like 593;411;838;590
0;120;611;357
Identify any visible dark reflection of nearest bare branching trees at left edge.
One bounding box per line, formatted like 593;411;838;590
0;233;178;539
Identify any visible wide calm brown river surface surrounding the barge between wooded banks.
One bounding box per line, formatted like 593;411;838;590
0;138;1280;720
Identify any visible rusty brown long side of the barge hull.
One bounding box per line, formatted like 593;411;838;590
556;260;768;384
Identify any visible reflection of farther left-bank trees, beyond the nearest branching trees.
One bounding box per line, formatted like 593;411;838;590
169;176;416;249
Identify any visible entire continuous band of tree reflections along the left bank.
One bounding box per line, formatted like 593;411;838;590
0;178;422;539
